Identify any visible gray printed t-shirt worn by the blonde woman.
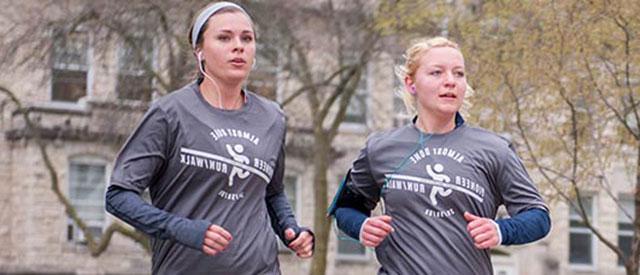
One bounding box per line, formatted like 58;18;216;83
349;124;547;274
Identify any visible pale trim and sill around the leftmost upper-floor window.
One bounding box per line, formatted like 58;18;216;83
47;28;95;106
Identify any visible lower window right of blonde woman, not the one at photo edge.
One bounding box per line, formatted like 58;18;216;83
569;196;596;266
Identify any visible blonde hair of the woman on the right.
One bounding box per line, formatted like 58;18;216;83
395;37;474;116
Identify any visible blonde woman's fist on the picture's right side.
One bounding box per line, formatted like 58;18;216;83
464;212;500;249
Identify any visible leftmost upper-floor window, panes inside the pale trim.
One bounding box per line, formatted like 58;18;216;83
51;32;89;102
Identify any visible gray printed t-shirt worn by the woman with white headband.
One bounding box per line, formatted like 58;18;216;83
111;83;286;274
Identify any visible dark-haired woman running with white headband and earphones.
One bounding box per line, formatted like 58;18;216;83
106;2;314;274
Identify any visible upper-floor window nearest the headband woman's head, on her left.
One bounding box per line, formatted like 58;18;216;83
116;37;153;101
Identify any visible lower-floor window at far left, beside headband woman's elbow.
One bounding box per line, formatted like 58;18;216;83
67;158;107;243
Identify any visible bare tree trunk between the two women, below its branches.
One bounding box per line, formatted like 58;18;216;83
310;134;331;275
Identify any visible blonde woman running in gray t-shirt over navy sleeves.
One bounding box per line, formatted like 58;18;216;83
330;37;551;274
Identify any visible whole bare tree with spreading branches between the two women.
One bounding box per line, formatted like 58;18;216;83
251;0;390;274
